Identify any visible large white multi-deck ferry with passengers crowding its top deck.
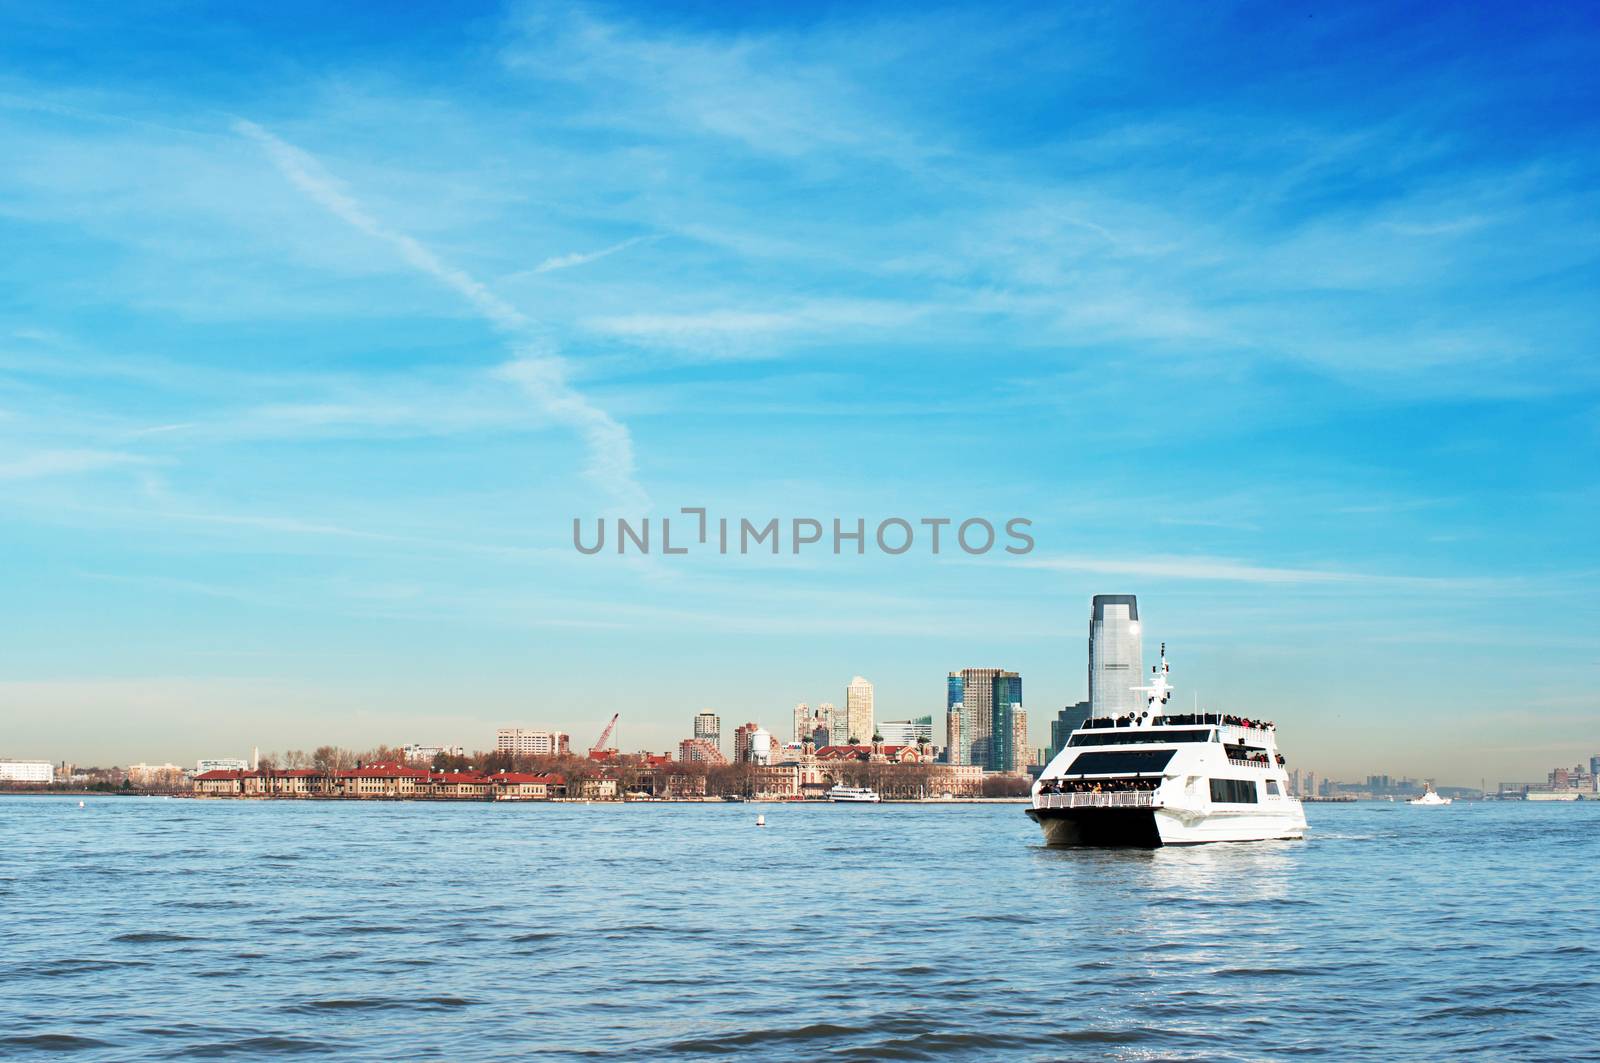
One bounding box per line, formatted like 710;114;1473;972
1027;642;1306;848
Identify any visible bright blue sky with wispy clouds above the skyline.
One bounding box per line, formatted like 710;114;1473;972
0;3;1600;784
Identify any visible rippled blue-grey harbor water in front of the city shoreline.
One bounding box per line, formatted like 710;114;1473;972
0;797;1600;1060
